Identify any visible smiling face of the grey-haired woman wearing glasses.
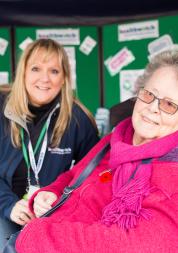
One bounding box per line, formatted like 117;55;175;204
132;67;178;145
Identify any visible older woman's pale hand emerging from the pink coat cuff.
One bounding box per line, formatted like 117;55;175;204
33;191;57;217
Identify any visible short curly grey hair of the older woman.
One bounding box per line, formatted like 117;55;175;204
135;49;178;92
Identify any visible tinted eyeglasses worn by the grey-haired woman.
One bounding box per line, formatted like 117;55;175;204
137;88;178;115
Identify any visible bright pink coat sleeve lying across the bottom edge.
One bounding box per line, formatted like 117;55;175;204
16;194;178;253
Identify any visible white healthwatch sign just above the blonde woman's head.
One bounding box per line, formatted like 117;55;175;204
36;28;80;45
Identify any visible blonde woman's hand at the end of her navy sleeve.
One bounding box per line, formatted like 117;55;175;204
10;199;35;226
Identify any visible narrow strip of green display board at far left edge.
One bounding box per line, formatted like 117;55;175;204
0;27;12;84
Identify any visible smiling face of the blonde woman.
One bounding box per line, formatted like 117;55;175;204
25;49;64;106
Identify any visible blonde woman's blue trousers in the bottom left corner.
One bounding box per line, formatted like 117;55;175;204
0;218;21;252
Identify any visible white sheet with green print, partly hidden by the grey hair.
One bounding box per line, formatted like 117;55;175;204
120;69;144;102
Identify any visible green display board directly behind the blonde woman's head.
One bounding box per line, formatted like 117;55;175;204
15;26;100;113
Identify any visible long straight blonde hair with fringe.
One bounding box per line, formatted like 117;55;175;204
7;39;96;147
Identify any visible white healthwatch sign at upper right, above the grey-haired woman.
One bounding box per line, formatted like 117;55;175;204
118;20;159;41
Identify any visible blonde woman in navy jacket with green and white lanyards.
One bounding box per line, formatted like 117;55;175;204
0;39;98;248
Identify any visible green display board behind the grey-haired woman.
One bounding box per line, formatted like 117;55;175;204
103;16;178;108
